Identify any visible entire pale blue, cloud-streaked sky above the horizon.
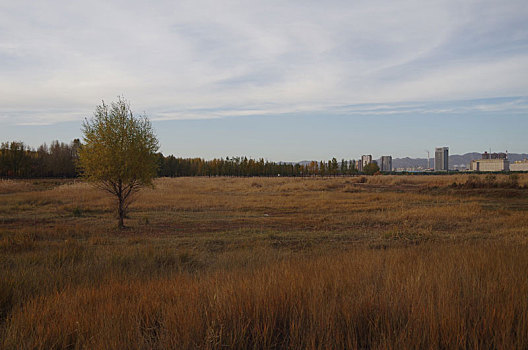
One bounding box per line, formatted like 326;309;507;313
0;0;528;161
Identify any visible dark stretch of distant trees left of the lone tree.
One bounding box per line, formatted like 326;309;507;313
0;139;81;178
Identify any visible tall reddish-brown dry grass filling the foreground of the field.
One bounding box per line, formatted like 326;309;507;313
2;245;528;349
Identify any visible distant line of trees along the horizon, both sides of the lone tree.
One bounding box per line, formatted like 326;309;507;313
0;139;366;178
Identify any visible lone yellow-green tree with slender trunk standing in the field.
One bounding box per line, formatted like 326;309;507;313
79;97;159;229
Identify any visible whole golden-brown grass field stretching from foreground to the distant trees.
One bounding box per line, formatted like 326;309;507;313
0;174;528;349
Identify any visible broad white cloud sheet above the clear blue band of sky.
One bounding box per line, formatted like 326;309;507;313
0;1;528;123
